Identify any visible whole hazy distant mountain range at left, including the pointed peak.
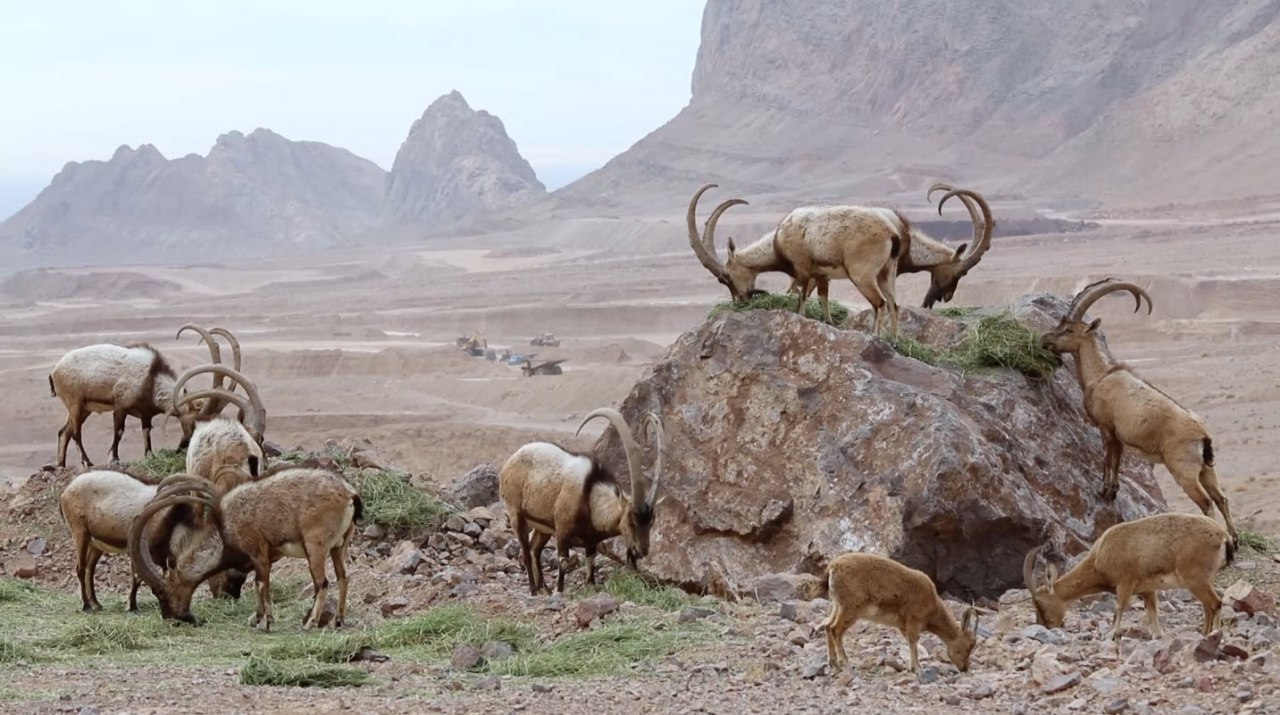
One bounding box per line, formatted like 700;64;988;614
0;92;545;265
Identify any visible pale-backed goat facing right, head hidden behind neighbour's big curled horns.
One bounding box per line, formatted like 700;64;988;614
58;469;226;611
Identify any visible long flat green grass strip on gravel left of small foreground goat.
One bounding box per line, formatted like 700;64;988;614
489;619;703;678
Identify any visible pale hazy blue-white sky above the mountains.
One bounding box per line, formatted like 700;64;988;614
0;0;703;217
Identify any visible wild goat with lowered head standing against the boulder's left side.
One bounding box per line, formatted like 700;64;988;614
498;407;664;595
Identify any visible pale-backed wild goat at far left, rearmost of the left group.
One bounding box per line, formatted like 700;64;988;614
49;343;204;467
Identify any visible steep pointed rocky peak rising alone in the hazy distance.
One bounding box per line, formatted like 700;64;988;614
384;91;547;225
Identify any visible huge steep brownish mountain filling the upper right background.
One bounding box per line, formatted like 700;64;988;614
557;0;1280;208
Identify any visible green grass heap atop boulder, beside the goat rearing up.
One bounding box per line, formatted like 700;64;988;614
892;312;1062;379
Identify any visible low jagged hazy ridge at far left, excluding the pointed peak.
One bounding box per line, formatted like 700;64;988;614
0;129;385;265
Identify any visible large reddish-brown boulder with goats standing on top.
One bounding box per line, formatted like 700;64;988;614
596;294;1165;597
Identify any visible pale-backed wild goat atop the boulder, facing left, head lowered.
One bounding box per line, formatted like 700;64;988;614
685;184;911;335
